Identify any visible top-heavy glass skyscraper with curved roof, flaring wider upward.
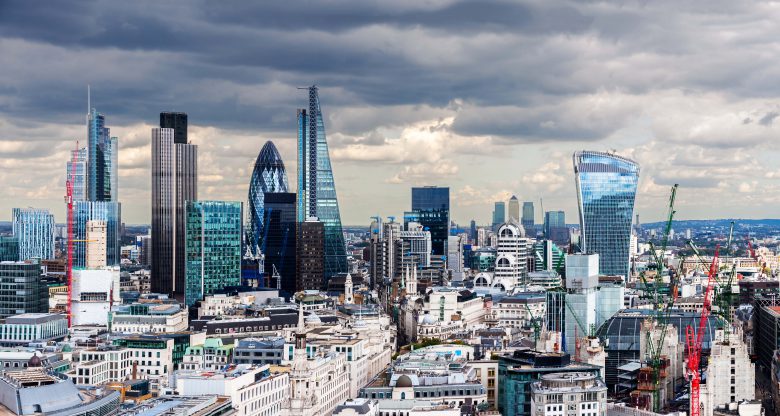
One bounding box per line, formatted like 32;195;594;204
573;151;639;277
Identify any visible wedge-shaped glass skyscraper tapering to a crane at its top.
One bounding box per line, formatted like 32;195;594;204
297;86;347;279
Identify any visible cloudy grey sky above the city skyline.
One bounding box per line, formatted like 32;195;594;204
0;0;780;225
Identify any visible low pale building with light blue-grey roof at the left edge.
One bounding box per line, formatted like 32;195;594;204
0;313;68;347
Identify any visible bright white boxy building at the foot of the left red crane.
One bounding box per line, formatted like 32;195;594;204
71;266;121;326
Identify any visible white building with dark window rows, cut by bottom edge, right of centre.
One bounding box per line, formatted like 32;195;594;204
531;372;607;416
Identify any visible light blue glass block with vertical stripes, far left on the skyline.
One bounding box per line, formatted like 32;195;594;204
11;208;55;261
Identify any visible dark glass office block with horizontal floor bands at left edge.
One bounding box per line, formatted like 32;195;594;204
0;259;49;319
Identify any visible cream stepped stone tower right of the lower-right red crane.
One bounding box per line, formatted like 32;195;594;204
700;330;756;415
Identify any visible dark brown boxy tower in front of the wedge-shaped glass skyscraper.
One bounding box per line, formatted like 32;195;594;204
295;218;326;291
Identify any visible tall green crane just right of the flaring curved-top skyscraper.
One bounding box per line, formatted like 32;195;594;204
640;184;679;412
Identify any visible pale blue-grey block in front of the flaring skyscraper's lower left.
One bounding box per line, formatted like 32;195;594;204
565;254;609;352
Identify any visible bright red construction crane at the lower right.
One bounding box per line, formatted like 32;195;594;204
685;246;719;416
